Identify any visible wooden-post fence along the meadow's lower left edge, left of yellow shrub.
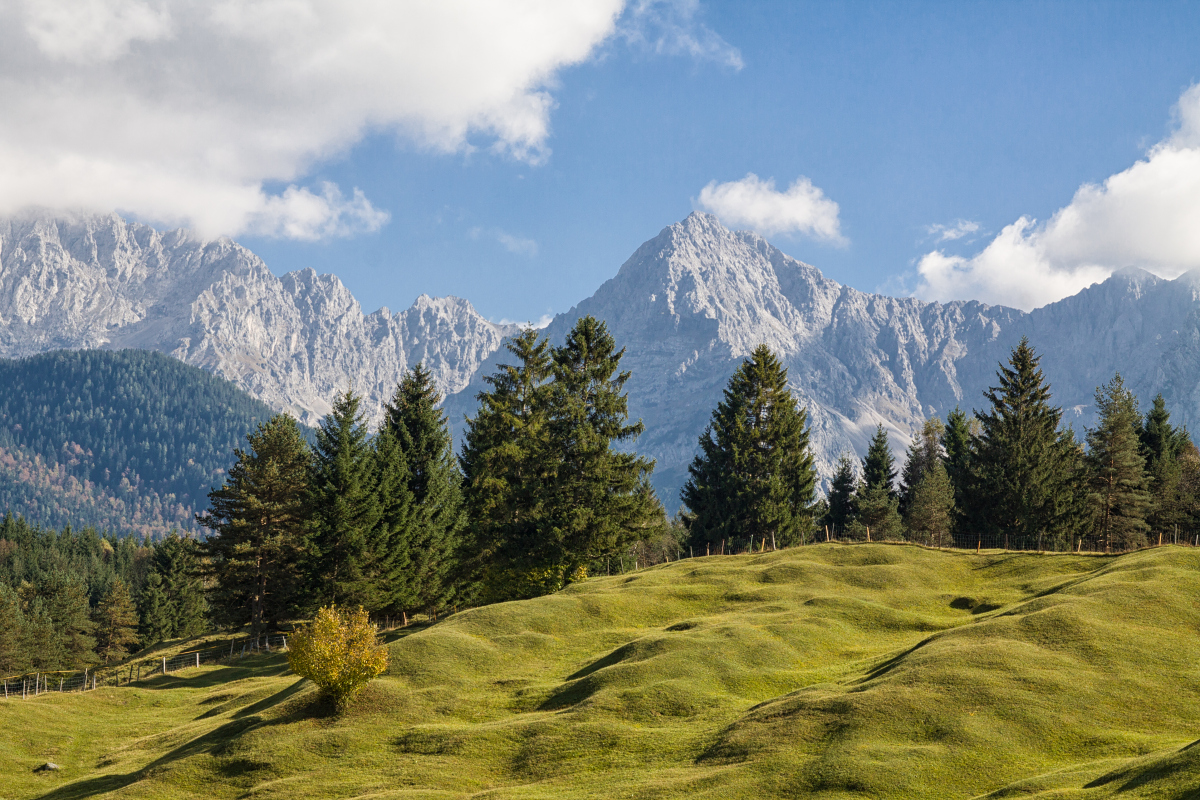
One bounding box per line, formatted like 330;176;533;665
0;633;288;699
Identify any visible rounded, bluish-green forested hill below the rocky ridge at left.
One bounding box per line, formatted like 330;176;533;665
0;350;283;535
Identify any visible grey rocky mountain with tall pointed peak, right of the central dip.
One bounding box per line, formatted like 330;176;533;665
448;213;1200;506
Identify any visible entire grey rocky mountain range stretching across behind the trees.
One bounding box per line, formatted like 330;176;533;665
0;213;1200;507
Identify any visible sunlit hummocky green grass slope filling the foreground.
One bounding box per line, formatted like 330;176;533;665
0;545;1200;799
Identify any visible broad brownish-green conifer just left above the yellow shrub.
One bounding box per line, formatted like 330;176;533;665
197;414;311;637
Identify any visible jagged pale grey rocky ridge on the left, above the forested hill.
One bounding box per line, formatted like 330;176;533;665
0;213;516;425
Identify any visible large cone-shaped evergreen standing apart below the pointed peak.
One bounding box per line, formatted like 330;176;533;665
682;344;816;546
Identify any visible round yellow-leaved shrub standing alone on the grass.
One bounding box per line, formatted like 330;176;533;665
288;607;388;709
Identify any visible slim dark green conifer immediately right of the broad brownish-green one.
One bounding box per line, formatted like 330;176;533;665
307;390;379;607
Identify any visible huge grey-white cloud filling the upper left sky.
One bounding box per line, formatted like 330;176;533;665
0;0;624;237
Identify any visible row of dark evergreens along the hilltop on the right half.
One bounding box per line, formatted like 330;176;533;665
683;339;1200;552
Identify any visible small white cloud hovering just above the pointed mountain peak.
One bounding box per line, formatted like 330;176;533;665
698;173;846;245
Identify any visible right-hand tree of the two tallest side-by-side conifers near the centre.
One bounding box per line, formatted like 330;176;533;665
541;317;667;590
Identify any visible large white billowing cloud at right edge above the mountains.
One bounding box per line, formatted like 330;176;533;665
916;85;1200;309
